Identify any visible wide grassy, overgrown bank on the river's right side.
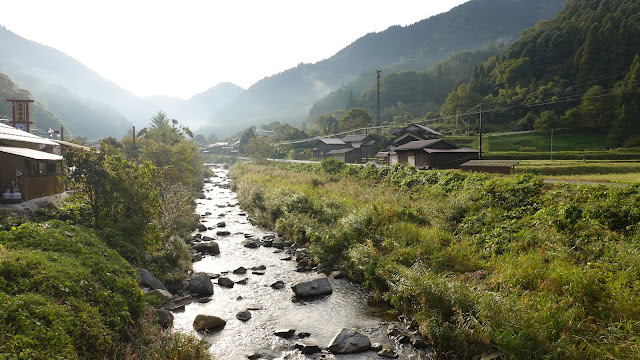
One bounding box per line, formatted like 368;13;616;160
231;160;640;359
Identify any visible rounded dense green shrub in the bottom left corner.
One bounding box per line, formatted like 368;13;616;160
0;221;143;359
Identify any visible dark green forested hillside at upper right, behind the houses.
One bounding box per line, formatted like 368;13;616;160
441;0;640;147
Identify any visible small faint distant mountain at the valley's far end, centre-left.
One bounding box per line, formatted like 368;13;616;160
146;82;244;129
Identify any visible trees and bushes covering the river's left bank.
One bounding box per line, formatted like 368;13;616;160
0;113;211;360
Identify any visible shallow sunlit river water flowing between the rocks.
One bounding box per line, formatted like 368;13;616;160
174;166;432;360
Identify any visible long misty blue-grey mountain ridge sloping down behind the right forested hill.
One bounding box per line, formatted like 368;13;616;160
210;0;564;135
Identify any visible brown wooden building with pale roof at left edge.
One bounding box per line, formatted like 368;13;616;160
0;124;63;201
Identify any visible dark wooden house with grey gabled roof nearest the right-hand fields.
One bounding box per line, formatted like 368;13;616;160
389;139;479;169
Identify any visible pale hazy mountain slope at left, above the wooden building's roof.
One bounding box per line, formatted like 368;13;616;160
0;26;158;137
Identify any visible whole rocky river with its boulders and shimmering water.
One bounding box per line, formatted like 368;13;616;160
149;166;432;360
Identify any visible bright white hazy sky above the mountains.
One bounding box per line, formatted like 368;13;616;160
0;0;468;99
